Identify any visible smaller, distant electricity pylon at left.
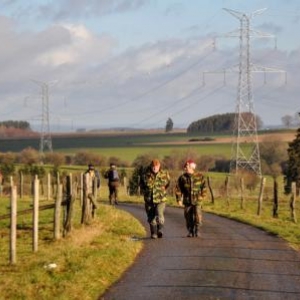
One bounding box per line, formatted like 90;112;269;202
32;80;53;154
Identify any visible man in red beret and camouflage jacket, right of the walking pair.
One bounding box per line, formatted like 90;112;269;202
176;160;206;237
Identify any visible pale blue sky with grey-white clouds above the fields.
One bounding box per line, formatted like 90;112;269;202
0;0;300;132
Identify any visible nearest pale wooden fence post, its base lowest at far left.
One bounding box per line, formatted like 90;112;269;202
10;186;17;264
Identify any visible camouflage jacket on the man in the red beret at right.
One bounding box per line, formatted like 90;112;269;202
176;172;207;206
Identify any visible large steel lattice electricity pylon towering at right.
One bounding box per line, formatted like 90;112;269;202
204;8;286;176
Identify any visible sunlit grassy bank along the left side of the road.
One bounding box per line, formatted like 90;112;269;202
0;197;145;300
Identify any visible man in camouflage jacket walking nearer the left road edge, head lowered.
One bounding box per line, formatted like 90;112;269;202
141;159;170;239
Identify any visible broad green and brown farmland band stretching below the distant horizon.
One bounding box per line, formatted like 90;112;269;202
0;130;296;161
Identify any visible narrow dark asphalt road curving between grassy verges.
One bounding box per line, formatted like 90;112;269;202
99;204;300;300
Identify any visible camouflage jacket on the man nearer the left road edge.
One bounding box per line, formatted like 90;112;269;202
141;167;170;203
